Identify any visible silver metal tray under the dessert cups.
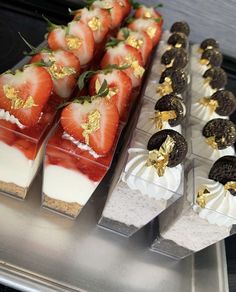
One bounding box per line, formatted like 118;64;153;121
0;174;228;292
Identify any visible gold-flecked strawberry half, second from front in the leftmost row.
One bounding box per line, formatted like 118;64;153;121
30;50;80;98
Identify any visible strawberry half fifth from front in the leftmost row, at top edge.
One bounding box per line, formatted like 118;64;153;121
92;0;123;29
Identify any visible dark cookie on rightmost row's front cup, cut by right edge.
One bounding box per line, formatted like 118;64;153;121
208;155;236;196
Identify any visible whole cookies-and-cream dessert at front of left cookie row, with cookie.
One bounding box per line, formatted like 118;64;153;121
99;130;187;236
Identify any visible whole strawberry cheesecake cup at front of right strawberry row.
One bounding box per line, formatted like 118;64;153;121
42;91;119;218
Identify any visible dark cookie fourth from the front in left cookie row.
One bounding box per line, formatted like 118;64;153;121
161;48;188;69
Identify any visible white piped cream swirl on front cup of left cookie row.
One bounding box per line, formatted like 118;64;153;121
122;143;182;200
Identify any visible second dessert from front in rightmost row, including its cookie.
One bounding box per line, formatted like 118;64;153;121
190;118;236;161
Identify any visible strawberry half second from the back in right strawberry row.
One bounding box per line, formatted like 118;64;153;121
128;18;162;46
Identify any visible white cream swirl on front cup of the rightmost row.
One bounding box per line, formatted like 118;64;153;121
194;166;236;227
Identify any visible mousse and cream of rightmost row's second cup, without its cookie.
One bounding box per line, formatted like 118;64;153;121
191;125;235;161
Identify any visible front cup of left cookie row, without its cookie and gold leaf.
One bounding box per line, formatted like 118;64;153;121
99;130;183;237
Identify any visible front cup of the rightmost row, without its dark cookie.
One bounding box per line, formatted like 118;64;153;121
152;159;236;259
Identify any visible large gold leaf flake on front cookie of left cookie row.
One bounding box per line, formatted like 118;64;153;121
146;135;175;176
